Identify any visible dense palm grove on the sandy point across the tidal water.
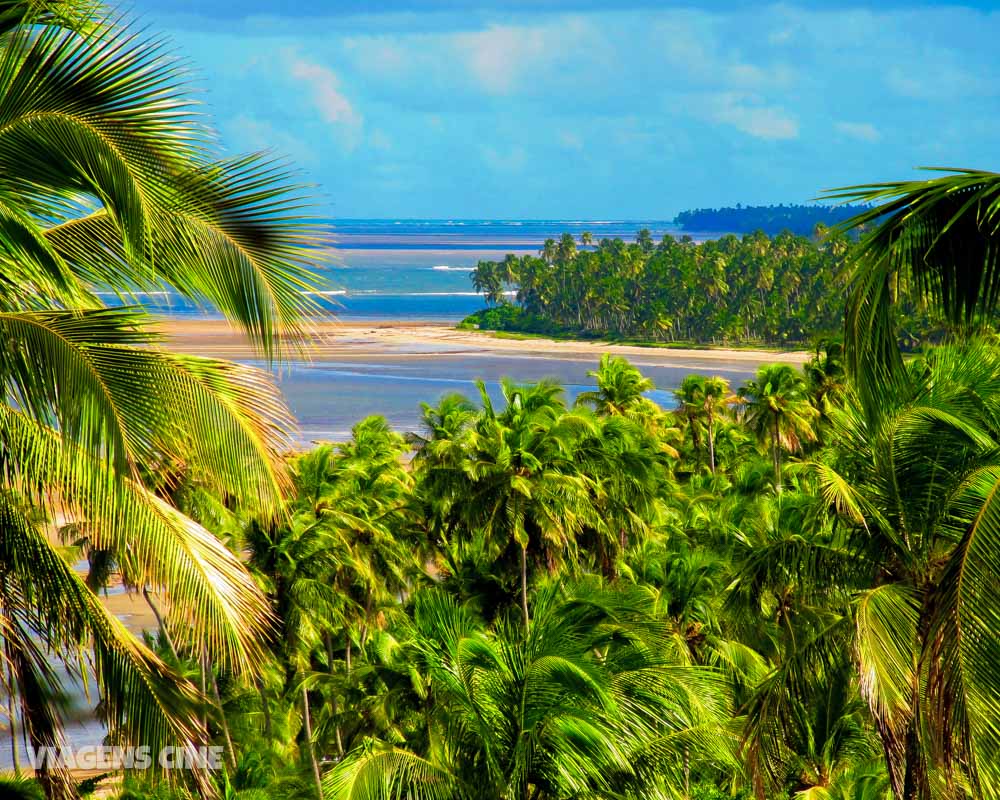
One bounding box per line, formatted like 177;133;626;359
466;227;940;345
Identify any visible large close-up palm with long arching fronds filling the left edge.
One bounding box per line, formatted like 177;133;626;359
0;2;320;797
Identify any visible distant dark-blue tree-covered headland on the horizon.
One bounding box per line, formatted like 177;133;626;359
674;203;865;236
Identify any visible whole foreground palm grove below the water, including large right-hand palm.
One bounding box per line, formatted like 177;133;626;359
74;342;1000;800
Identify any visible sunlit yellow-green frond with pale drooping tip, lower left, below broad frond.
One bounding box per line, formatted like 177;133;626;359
0;405;270;669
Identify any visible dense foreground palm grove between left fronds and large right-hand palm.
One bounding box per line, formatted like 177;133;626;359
230;344;928;800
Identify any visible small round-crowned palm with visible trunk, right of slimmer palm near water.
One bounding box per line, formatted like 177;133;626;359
738;364;818;492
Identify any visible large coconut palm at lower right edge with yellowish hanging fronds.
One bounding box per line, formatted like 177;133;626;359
739;342;1000;800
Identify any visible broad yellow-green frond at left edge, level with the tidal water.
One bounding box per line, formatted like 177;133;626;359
0;309;291;510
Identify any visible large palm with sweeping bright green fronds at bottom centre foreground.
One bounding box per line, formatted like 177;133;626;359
324;584;732;800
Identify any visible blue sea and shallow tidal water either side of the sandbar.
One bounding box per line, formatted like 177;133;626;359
99;219;750;446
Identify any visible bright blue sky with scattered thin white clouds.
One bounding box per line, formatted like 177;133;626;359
139;0;1000;219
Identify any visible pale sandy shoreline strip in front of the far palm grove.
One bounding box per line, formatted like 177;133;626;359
159;318;810;366
